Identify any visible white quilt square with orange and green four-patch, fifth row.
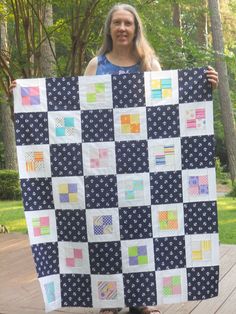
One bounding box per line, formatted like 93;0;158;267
151;203;184;238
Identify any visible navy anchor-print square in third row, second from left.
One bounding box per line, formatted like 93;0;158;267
50;144;83;177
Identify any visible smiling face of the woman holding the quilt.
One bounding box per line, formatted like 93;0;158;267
110;10;135;47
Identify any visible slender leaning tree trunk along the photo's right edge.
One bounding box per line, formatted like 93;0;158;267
208;0;236;181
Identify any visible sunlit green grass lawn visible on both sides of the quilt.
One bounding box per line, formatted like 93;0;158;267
0;197;236;244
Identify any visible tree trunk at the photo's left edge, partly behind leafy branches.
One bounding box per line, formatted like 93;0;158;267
0;18;17;170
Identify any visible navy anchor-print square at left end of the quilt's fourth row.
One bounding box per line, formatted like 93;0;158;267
20;178;54;211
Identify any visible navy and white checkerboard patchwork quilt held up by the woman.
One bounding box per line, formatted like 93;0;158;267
14;68;219;311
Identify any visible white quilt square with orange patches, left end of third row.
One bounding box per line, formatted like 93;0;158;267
16;145;51;179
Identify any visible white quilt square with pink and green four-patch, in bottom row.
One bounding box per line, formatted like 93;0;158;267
156;268;188;304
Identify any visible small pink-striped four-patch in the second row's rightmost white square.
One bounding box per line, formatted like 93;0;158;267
186;108;206;130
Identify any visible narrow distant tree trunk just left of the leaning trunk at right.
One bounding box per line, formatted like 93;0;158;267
197;0;208;49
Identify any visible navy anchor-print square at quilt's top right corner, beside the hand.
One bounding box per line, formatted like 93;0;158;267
178;68;212;104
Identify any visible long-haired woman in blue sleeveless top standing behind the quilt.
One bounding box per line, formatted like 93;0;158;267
85;4;218;314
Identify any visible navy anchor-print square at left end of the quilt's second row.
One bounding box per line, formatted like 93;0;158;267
15;112;49;145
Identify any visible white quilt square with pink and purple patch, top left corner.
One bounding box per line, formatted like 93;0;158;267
13;78;48;113
